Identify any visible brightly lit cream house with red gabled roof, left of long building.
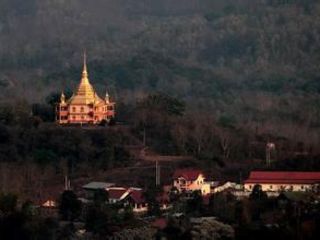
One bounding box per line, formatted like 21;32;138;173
173;169;211;195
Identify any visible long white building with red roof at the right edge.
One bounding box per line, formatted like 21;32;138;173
244;171;320;192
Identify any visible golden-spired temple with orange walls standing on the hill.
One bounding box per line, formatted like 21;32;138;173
56;54;115;124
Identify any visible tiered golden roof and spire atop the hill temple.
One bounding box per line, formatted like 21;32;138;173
68;54;103;105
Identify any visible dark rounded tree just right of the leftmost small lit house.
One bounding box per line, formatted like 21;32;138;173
59;190;82;221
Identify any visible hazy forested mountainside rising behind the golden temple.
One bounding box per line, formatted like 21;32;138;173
0;0;320;146
